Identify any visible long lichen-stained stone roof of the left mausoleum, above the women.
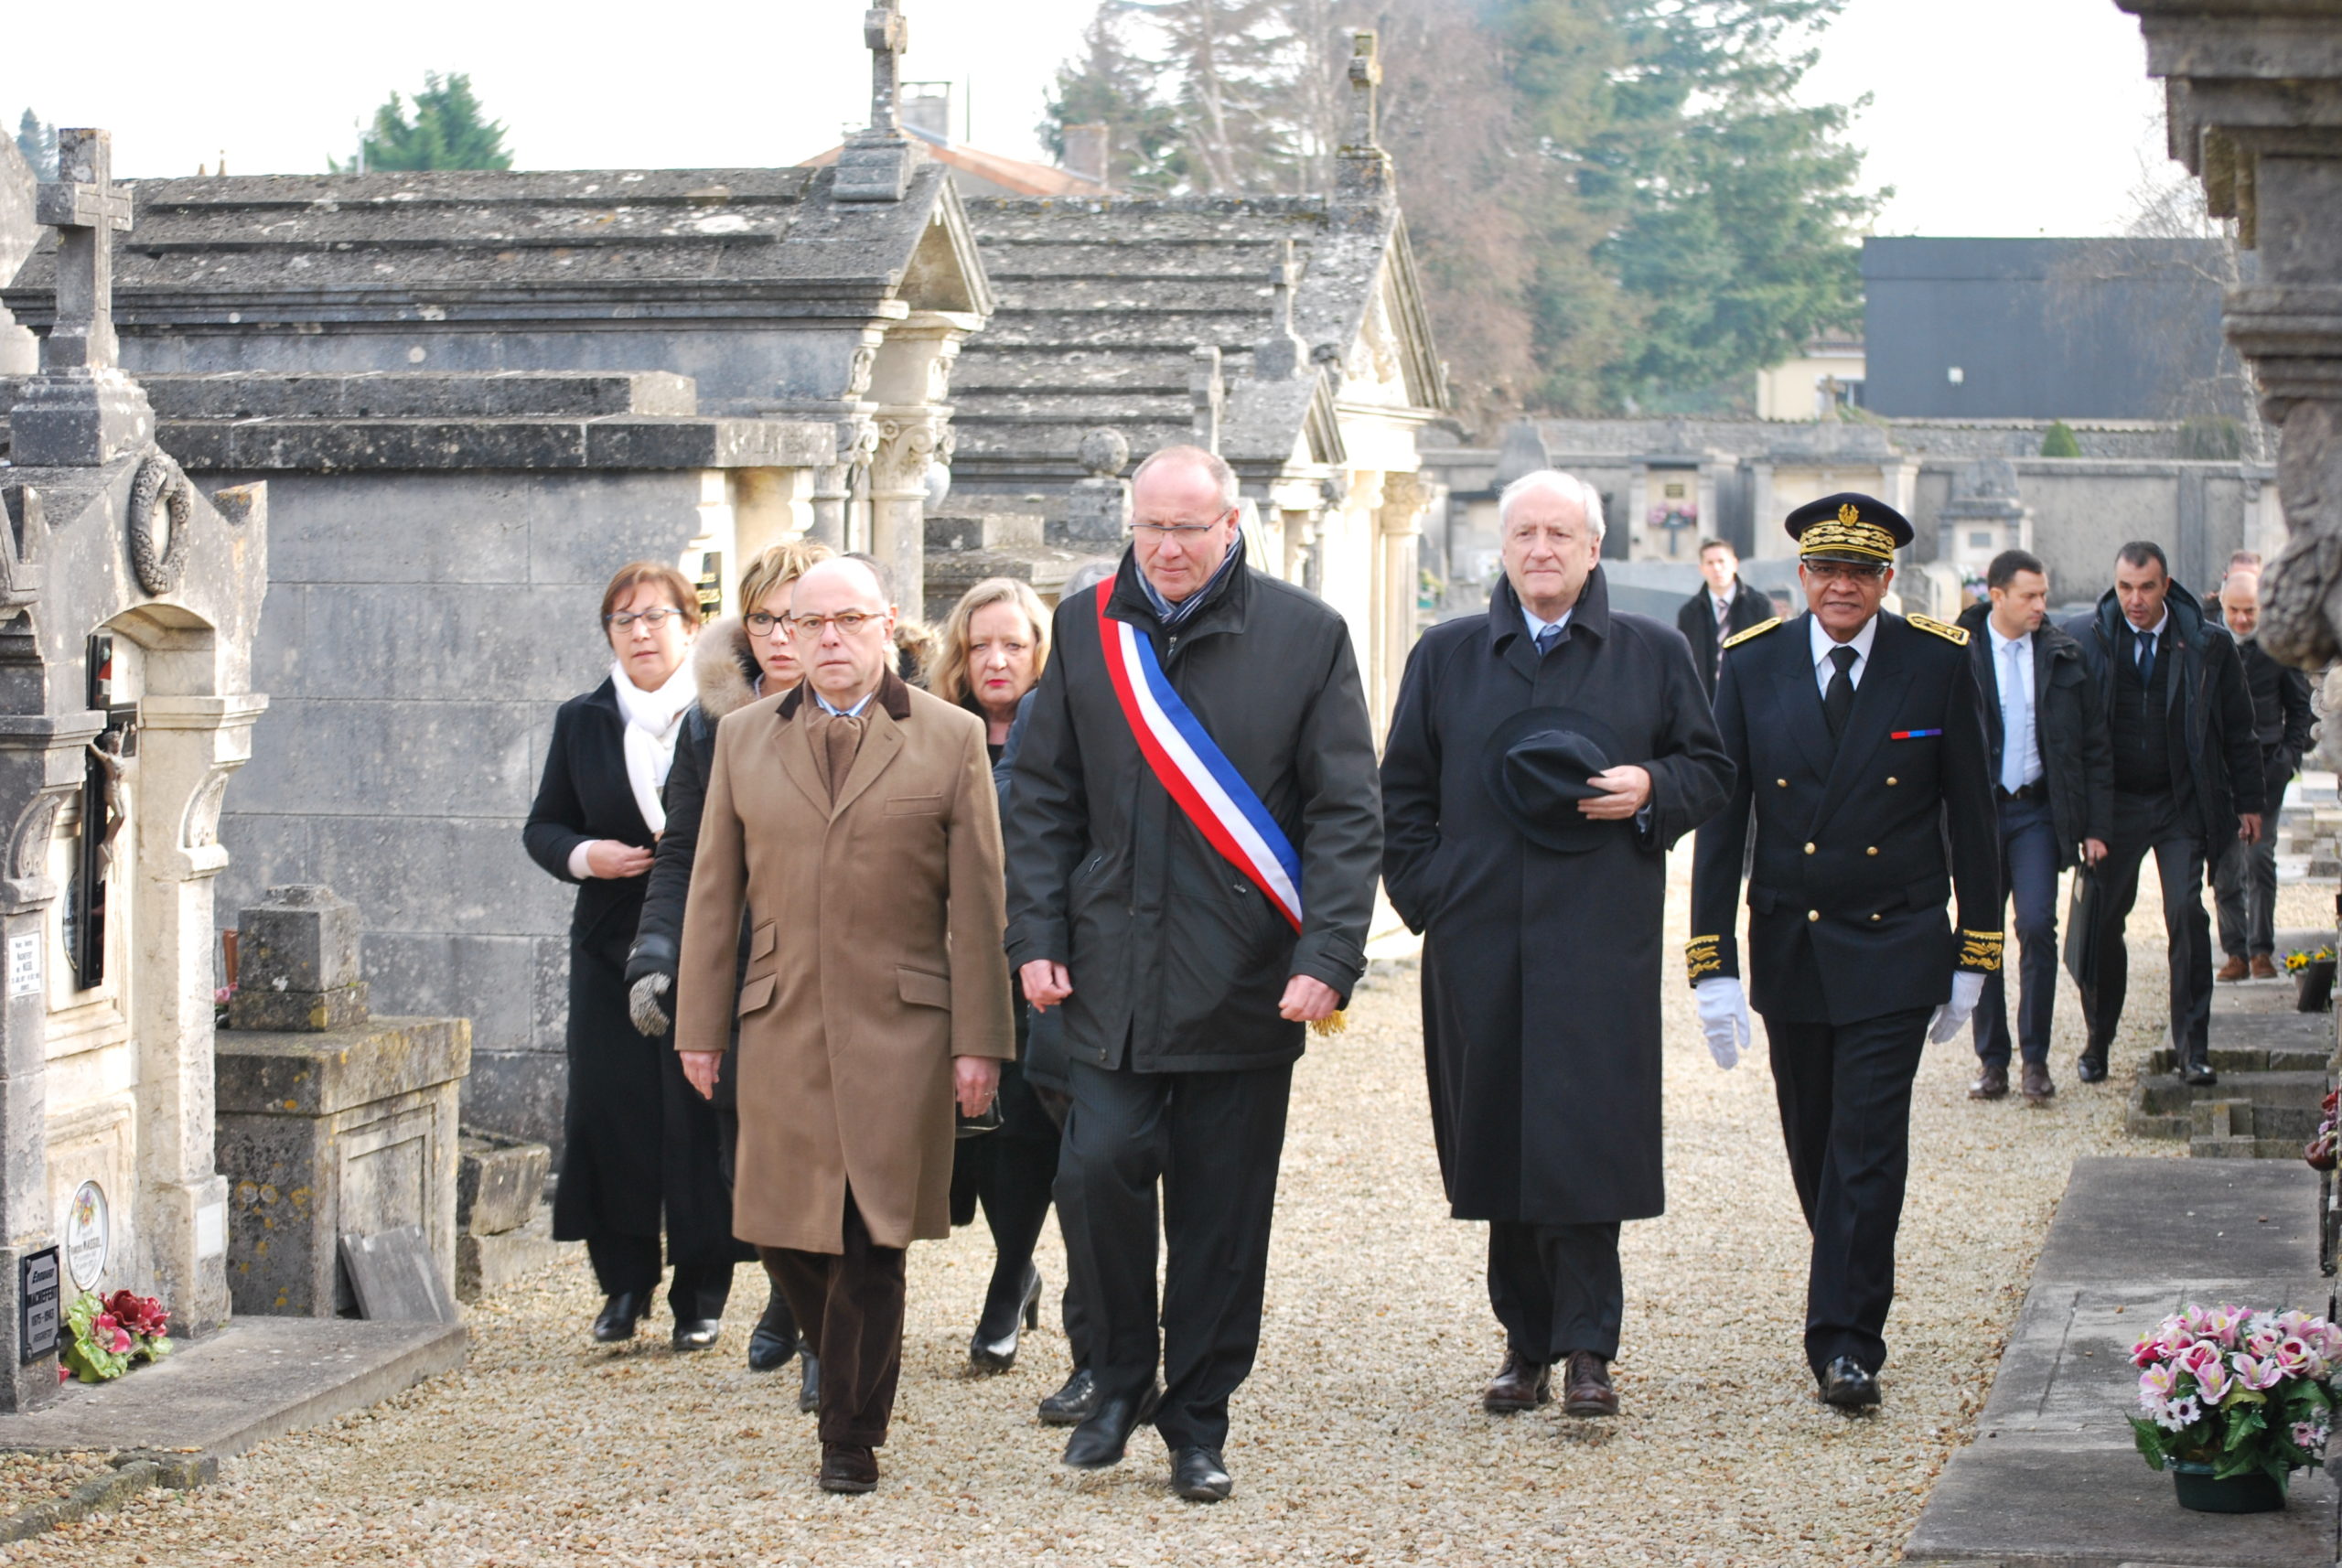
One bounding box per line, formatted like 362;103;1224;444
5;164;988;330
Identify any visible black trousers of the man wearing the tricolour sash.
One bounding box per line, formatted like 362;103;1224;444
1063;1062;1293;1449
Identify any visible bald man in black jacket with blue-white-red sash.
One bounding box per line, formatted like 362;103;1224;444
1007;447;1381;1502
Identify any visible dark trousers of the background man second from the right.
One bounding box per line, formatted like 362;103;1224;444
2082;789;2211;1062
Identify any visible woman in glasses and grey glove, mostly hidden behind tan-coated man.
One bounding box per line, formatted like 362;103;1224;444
626;541;833;1412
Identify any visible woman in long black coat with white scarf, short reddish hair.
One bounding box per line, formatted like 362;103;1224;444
522;562;743;1350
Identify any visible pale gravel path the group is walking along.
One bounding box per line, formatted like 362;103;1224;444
14;856;2330;1568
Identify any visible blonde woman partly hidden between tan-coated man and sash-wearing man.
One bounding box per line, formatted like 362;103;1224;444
929;578;1058;1371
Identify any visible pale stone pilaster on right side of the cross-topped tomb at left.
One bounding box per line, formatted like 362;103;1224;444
131;693;269;1334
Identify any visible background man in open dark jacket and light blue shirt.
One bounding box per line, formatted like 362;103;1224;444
1961;550;2115;1104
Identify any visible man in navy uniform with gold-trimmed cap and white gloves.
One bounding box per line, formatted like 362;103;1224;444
1686;494;2000;1409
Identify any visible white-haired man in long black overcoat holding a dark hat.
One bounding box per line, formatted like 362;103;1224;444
1381;470;1731;1416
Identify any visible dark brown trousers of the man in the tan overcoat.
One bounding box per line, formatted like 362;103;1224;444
757;1187;908;1449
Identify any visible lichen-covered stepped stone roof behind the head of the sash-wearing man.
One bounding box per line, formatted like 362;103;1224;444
951;197;1445;489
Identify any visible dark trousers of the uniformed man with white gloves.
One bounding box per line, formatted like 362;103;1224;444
1764;1006;1935;1376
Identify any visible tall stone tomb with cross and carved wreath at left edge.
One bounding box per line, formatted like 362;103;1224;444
0;129;267;1412
